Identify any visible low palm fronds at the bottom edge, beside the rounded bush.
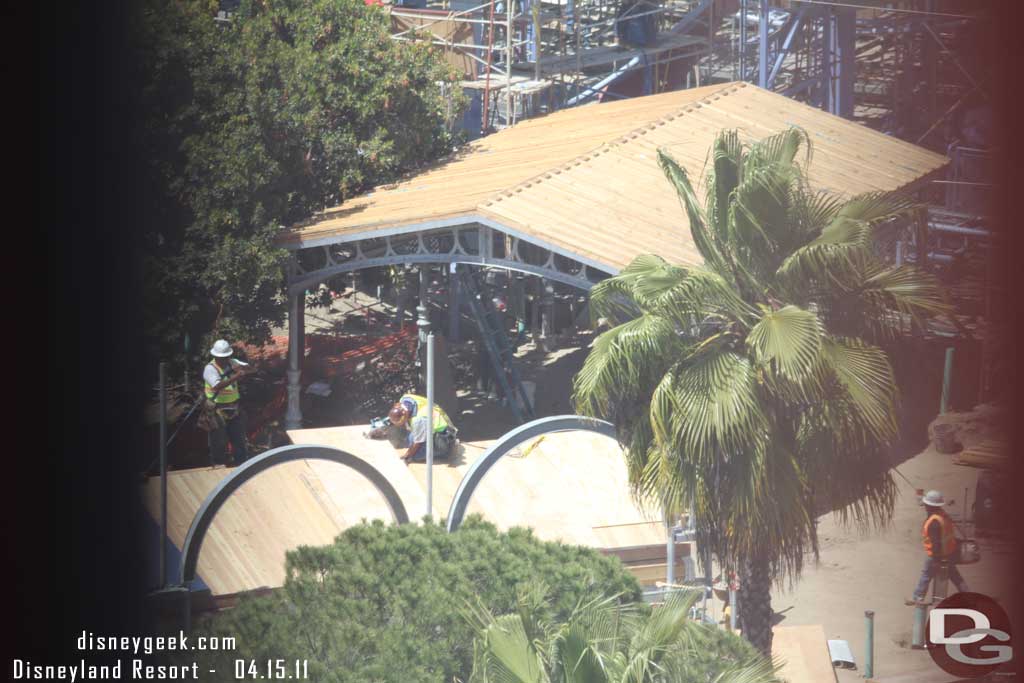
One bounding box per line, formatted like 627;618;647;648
466;586;778;683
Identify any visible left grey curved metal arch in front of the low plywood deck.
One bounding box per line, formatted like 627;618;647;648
178;445;409;587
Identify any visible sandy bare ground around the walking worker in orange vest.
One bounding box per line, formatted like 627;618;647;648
772;409;1018;682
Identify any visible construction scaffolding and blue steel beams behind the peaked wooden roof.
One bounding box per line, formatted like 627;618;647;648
391;0;991;145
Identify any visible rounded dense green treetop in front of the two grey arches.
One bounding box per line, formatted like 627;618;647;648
177;517;641;683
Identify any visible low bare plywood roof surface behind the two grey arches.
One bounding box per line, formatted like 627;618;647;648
143;426;665;596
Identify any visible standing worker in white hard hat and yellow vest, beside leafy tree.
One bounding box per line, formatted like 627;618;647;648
203;339;255;465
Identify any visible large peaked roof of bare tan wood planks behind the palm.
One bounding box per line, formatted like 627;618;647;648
281;83;948;271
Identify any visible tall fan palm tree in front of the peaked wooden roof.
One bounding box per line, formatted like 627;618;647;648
574;128;949;654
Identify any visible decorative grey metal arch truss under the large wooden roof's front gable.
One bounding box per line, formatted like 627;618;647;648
288;223;612;296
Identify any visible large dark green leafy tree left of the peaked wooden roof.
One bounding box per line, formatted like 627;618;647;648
130;0;458;356
